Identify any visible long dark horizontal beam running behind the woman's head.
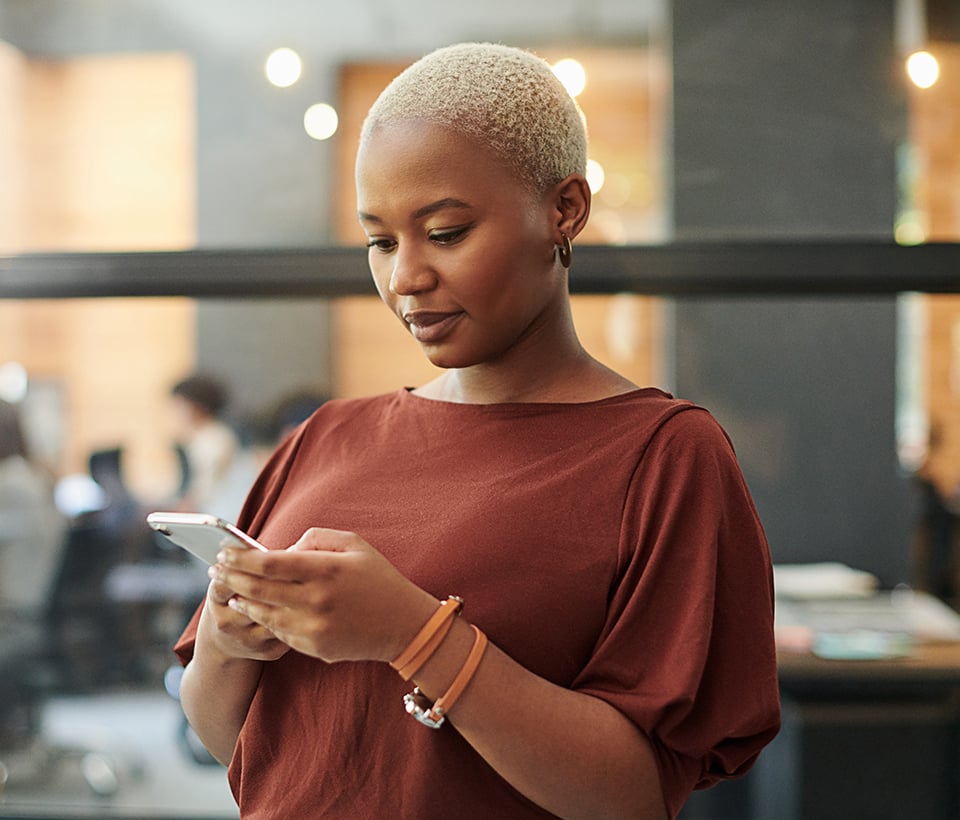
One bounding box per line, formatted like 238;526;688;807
0;241;960;299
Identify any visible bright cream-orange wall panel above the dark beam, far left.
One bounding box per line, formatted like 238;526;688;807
23;54;196;251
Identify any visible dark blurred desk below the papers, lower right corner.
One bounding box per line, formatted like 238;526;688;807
749;642;960;820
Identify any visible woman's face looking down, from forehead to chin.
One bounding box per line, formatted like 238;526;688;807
357;121;566;368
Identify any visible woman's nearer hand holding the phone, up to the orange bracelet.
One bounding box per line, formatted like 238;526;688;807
215;528;438;662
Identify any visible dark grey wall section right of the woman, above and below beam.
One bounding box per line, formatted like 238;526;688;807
673;0;911;583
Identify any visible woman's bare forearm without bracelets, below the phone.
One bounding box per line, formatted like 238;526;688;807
180;612;263;766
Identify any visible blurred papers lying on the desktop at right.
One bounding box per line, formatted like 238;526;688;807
774;564;960;660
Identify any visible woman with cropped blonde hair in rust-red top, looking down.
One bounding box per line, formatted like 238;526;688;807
178;44;779;818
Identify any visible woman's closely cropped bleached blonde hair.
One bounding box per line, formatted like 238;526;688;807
360;43;587;193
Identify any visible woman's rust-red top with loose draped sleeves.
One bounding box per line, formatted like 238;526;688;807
176;388;780;820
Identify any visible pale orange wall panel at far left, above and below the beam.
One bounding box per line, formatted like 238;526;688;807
0;46;196;497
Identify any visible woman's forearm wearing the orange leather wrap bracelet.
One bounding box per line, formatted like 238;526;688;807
416;623;666;820
